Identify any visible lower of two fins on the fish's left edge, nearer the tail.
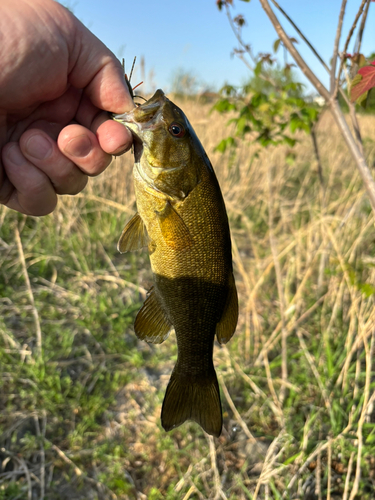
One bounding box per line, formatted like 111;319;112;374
134;287;173;344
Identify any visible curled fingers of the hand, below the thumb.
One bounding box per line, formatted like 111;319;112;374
0;112;131;215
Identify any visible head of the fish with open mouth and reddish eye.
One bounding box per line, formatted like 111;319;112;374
114;89;205;200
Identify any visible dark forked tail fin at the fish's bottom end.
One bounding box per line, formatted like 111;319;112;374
161;371;223;437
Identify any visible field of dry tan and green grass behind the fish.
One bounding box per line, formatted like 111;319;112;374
0;101;375;500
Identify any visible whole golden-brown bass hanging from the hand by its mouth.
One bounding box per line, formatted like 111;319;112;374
114;89;238;437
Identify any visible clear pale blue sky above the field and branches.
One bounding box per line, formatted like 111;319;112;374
68;0;375;92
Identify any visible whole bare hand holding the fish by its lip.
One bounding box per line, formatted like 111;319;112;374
0;0;134;215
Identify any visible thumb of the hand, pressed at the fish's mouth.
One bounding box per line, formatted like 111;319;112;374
68;11;135;114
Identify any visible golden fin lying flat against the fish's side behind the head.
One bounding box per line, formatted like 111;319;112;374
156;202;193;250
